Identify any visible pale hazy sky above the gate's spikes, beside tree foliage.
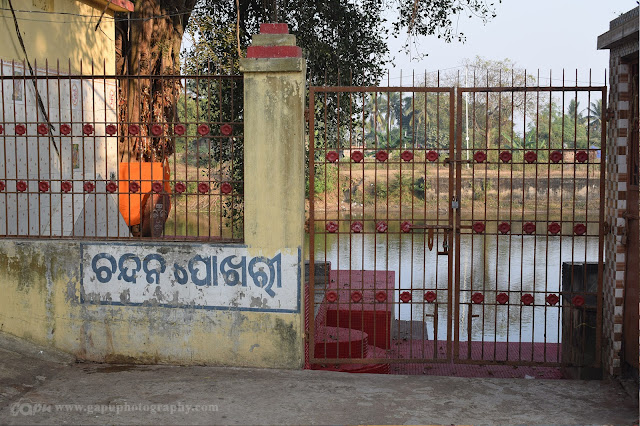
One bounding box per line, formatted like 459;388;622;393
389;0;637;85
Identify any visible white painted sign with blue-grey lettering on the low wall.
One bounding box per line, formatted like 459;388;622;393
81;243;301;312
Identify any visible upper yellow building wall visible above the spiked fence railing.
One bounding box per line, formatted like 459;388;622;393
0;0;115;75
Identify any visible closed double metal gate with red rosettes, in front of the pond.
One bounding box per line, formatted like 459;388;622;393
307;79;606;372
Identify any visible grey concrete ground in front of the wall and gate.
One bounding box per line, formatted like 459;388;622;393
0;334;638;424
